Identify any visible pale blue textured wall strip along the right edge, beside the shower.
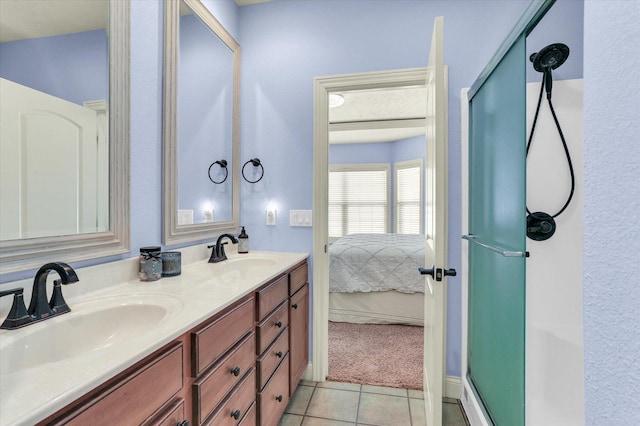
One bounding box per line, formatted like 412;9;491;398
583;0;640;425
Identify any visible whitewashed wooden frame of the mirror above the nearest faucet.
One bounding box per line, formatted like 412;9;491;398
0;0;130;273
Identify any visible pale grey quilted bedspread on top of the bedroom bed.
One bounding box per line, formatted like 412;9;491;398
329;234;425;294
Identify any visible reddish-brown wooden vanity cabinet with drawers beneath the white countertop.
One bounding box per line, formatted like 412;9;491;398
39;260;309;426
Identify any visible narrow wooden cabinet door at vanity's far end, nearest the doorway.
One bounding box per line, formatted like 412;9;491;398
289;284;309;395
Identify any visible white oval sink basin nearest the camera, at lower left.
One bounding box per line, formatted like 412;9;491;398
0;295;182;375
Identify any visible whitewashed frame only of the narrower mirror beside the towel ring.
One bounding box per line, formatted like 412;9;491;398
162;0;240;244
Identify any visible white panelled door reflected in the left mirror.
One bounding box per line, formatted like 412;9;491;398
0;79;101;240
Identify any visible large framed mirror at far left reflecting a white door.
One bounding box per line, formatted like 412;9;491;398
0;0;129;273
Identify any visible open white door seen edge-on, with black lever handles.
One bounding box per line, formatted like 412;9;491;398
421;17;455;426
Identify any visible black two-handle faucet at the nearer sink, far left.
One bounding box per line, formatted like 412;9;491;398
0;262;78;329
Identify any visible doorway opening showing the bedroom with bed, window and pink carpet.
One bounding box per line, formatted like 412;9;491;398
327;82;427;391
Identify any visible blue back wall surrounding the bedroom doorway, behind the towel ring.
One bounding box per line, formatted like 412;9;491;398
239;0;528;376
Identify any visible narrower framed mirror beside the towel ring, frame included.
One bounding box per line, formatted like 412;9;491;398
163;0;240;244
